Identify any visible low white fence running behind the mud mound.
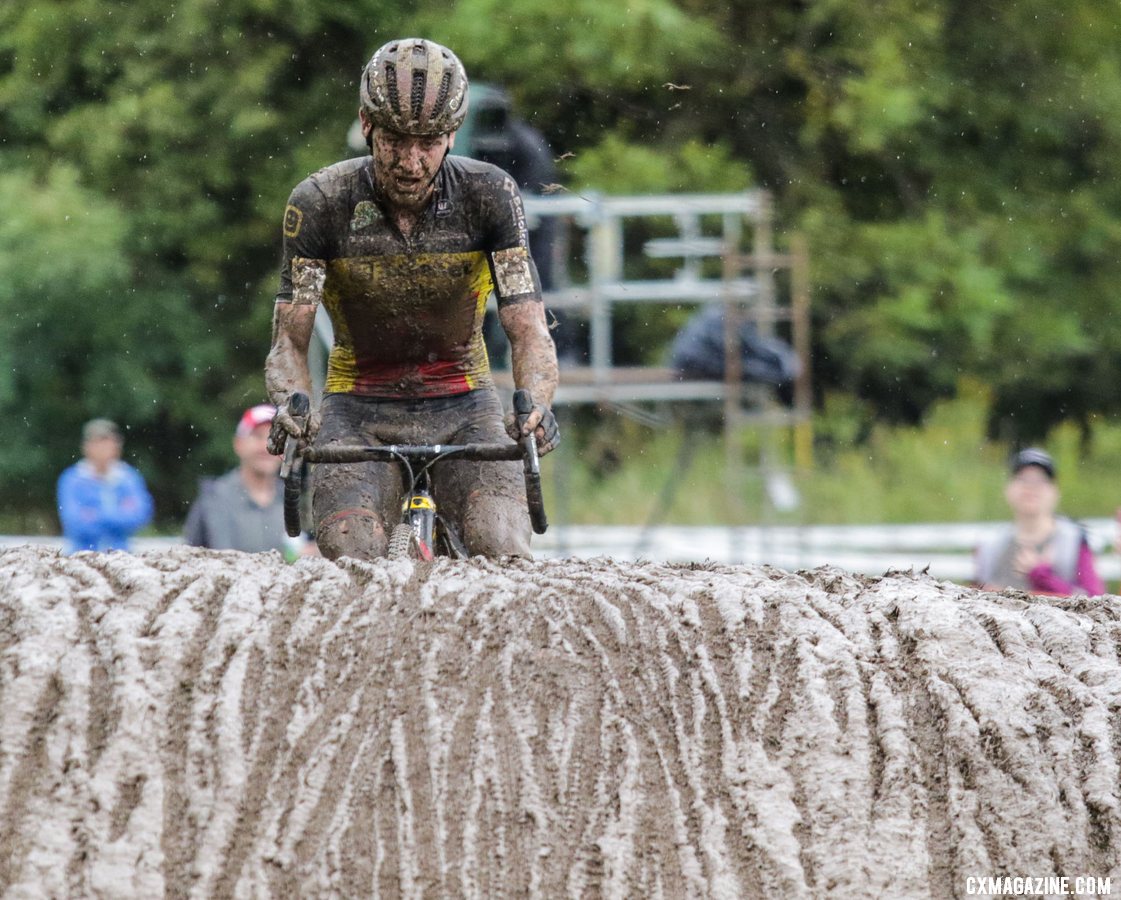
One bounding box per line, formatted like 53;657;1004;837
0;519;1121;582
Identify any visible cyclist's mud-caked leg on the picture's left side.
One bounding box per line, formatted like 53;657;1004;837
312;393;401;559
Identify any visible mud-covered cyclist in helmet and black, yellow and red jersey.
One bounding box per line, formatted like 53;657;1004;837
266;38;559;559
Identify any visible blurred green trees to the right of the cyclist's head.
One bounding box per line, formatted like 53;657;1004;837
434;0;1121;439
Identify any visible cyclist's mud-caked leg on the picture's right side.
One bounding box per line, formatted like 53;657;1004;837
433;390;531;558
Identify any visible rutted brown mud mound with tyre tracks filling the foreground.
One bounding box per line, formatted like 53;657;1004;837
0;547;1121;900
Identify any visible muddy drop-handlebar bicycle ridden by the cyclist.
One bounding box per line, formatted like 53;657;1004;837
280;390;548;560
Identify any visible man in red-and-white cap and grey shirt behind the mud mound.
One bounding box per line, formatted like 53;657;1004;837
183;403;313;560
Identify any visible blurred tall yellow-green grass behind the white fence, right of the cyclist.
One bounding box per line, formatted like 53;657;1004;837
544;387;1121;525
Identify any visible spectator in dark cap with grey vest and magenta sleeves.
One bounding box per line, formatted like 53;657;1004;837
976;447;1105;596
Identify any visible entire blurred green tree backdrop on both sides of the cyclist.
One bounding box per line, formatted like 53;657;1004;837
0;0;1121;527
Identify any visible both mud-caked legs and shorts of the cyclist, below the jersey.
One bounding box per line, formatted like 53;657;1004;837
312;390;530;559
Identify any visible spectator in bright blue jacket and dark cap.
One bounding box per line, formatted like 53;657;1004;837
58;419;152;554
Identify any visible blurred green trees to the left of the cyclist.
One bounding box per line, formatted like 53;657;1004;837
0;0;412;527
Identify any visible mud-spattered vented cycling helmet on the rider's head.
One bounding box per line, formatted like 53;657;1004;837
360;38;467;134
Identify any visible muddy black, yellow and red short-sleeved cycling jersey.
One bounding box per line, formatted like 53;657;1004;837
277;156;540;398
